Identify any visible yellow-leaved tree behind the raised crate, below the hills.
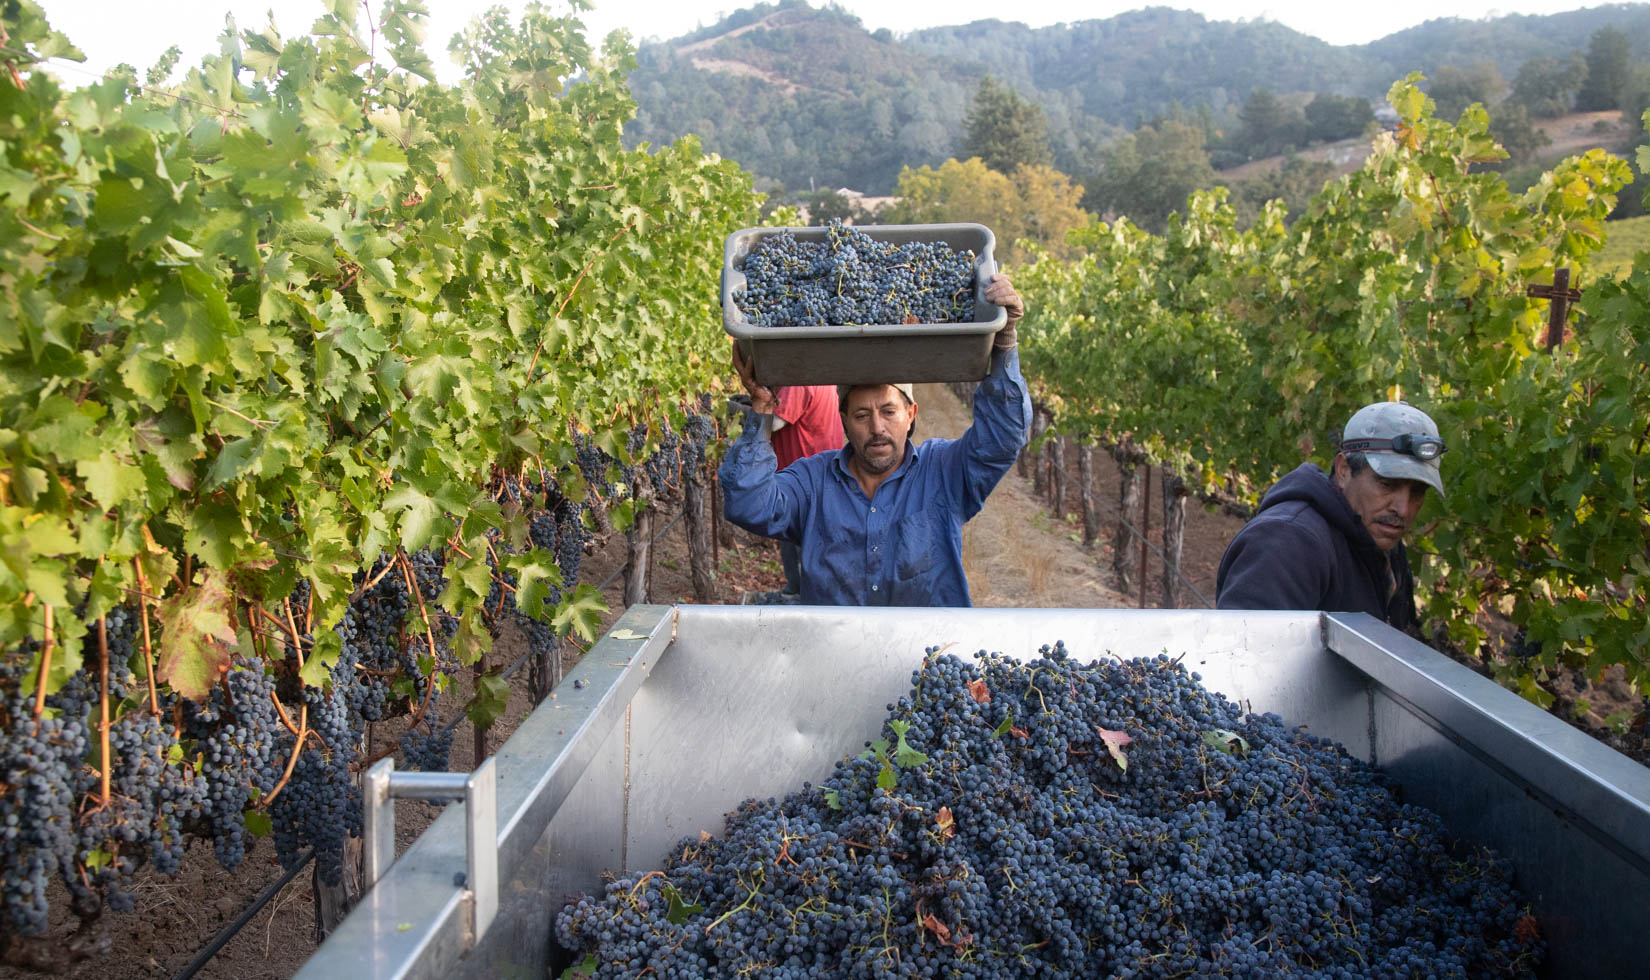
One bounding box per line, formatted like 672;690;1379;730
886;157;1089;264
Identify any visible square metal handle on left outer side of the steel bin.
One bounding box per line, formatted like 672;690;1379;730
361;759;498;949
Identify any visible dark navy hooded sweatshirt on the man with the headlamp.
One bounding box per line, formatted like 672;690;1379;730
1214;464;1416;630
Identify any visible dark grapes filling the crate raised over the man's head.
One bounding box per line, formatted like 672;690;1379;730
734;219;975;327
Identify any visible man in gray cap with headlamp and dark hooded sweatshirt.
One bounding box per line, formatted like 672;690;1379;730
1214;401;1444;629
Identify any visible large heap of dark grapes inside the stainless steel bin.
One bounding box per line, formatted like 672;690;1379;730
556;645;1541;978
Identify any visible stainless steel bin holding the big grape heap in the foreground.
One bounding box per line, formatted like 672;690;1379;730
299;605;1650;980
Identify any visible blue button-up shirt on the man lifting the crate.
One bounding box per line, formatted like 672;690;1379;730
719;348;1031;605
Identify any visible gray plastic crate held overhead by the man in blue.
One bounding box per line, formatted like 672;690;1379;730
721;224;1008;384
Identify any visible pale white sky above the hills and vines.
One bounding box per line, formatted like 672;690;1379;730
36;0;1594;86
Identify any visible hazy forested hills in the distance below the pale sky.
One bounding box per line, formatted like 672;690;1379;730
627;0;1650;195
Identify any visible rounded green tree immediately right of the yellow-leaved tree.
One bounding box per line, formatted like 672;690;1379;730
1082;119;1218;231
